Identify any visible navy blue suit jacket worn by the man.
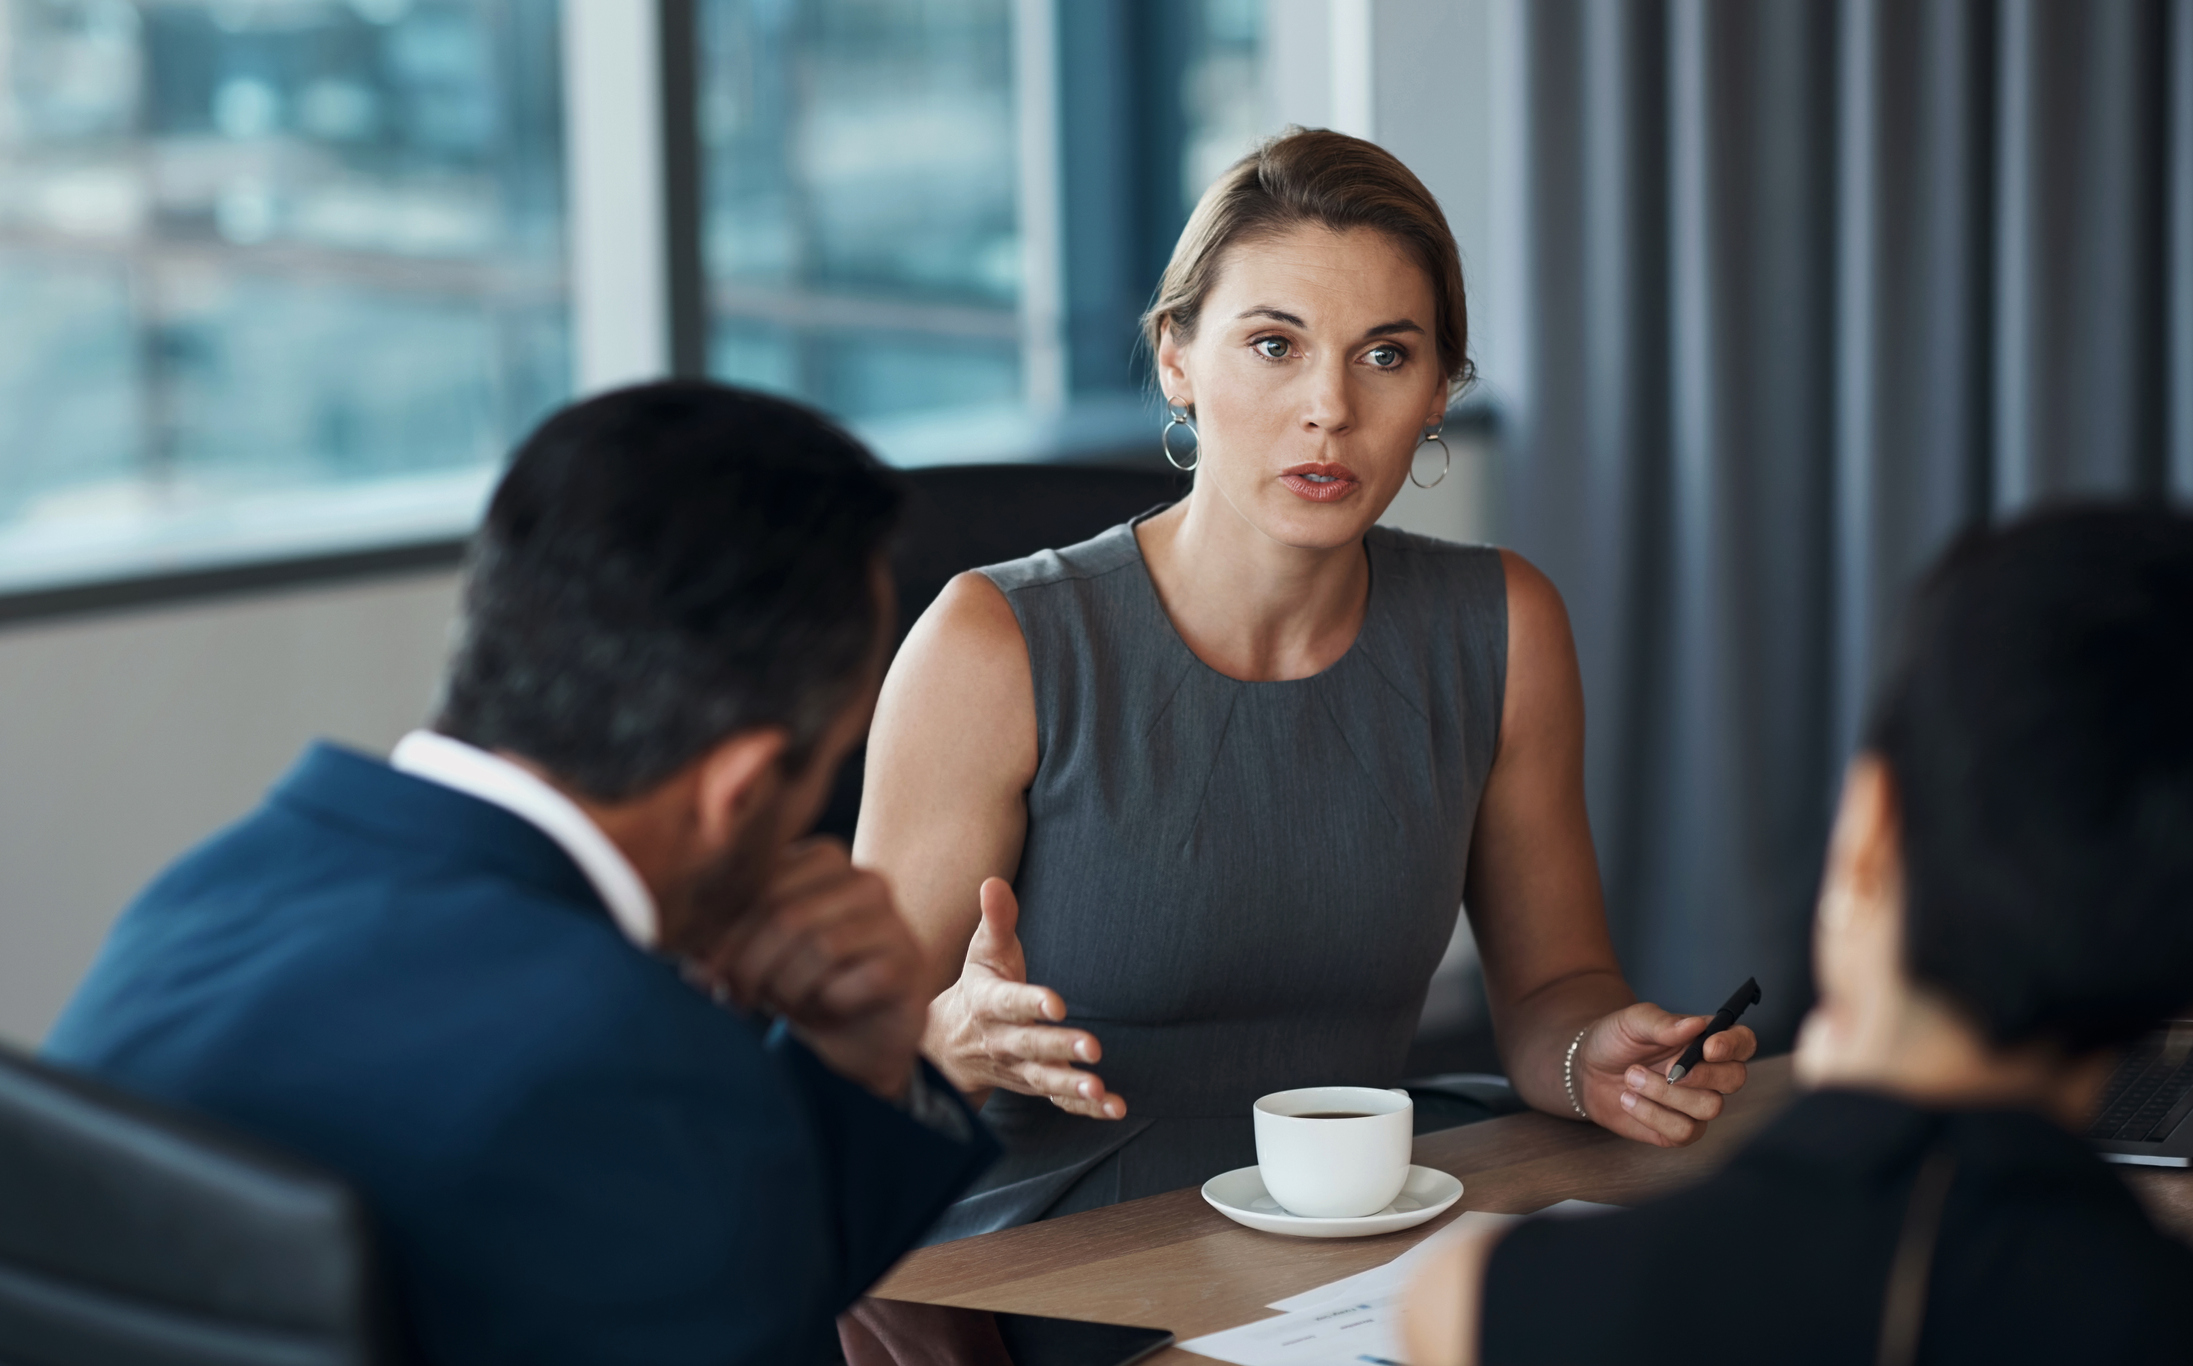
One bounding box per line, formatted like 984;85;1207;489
46;745;996;1366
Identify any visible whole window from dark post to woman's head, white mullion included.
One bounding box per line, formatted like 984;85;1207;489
700;0;1265;463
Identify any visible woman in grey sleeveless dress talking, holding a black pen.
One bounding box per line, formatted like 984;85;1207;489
855;132;1754;1237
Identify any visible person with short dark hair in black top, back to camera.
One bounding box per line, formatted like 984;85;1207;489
1410;511;2193;1366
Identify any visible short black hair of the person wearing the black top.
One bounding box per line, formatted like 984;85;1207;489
1868;509;2193;1052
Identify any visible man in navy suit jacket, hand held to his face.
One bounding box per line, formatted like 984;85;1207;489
46;384;996;1366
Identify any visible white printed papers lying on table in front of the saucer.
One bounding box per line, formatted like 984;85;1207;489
1180;1199;1616;1366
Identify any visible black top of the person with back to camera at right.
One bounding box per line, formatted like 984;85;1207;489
1482;1092;2193;1366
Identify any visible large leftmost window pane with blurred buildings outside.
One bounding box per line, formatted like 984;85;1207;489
0;0;570;588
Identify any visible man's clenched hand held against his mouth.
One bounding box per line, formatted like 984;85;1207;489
706;838;928;1101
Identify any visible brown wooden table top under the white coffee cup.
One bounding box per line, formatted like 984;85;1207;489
871;1057;2193;1366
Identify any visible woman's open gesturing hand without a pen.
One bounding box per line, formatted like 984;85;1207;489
921;877;1127;1120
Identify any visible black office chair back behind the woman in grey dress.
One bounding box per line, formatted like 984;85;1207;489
816;465;1189;840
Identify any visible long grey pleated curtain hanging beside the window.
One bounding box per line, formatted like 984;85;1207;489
1507;0;2193;1044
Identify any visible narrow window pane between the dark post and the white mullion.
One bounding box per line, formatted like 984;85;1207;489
700;0;1022;431
